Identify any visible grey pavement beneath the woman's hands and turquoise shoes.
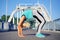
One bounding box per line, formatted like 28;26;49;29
0;29;60;40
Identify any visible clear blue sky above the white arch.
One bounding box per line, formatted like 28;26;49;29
0;0;60;20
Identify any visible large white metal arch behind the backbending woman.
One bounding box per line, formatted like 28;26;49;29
8;5;51;22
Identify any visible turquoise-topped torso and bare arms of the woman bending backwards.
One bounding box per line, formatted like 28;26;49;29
18;9;33;37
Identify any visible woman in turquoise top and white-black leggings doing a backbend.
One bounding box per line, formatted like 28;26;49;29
18;9;45;37
